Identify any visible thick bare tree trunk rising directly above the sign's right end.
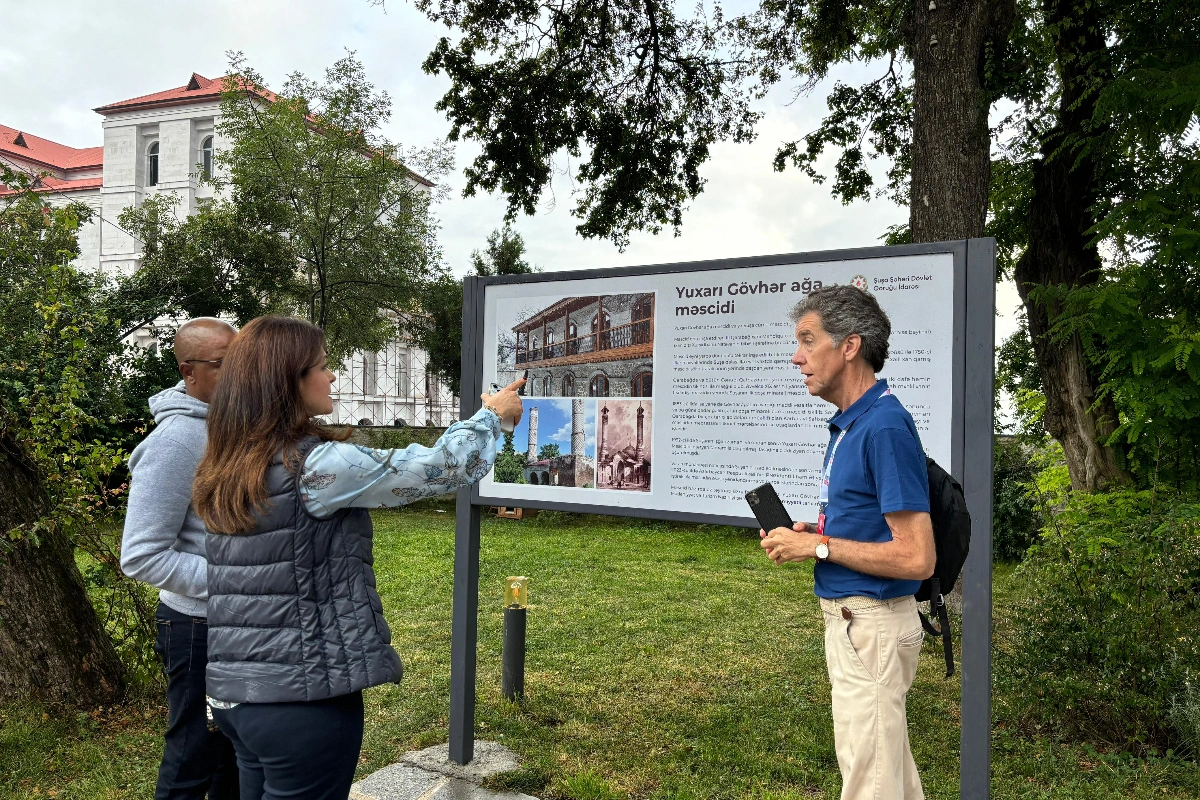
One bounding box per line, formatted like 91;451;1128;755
904;0;1015;242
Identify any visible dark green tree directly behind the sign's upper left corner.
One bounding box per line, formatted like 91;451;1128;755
408;225;536;395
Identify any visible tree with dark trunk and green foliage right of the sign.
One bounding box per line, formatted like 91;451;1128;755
992;0;1200;489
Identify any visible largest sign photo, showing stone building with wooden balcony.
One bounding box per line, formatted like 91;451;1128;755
497;291;654;397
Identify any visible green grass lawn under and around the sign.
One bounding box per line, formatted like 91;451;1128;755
0;504;1200;800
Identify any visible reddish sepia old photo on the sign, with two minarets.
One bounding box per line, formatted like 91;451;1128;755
596;399;653;492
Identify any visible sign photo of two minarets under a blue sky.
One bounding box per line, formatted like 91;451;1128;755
494;397;596;489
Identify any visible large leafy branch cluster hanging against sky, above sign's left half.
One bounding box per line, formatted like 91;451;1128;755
416;0;760;246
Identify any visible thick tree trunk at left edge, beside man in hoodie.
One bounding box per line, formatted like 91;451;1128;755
0;437;125;708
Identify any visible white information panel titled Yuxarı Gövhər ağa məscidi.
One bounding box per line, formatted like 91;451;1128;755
478;252;964;525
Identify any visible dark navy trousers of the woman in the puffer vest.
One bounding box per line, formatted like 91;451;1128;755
212;692;362;800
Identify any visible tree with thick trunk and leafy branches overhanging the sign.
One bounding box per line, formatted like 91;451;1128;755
418;0;1015;245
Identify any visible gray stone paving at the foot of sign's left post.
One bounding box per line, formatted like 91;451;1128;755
349;741;538;800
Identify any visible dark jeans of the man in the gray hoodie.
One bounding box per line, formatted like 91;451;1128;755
154;603;238;800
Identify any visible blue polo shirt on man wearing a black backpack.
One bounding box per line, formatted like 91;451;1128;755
814;380;929;600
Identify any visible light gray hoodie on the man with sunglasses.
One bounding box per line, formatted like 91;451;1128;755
121;381;209;616
